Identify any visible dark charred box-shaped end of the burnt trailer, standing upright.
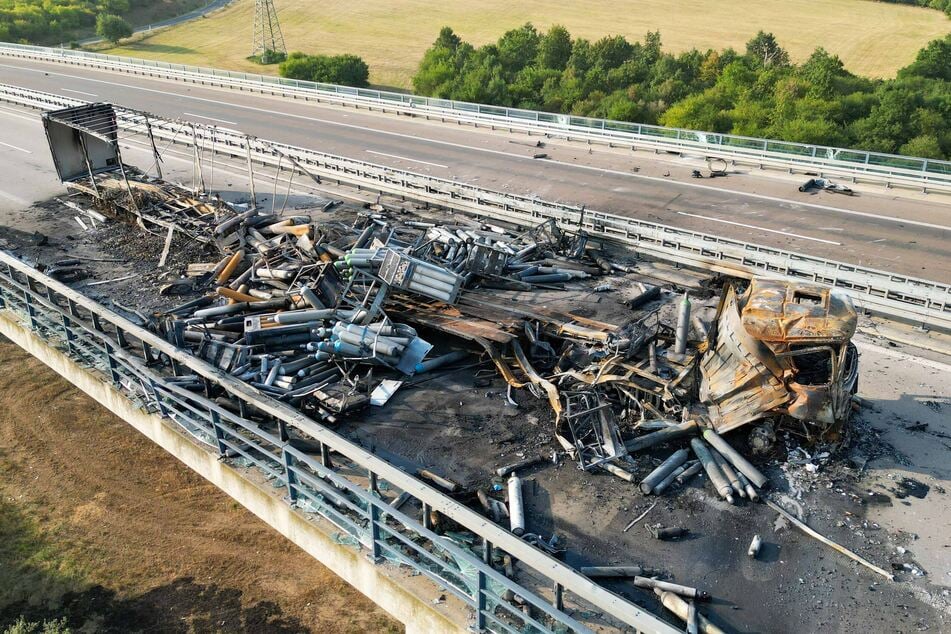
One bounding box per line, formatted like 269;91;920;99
43;103;121;183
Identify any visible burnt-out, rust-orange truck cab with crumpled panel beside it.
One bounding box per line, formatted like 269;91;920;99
700;279;858;437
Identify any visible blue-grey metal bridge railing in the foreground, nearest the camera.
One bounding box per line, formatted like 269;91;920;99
0;251;679;634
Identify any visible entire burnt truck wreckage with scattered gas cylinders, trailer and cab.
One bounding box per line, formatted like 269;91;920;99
24;104;884;628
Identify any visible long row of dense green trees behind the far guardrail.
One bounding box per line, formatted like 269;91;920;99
413;26;951;158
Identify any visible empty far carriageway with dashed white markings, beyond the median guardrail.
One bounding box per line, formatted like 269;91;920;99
0;59;951;281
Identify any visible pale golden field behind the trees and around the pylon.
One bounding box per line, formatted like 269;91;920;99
98;0;951;88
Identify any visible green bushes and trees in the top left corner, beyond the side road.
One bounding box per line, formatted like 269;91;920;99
0;0;204;45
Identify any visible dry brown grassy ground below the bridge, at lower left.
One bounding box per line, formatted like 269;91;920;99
0;338;403;634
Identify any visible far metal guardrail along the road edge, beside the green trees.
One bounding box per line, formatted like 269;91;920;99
0;43;951;193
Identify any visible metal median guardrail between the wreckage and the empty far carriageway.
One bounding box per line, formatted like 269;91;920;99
0;84;951;332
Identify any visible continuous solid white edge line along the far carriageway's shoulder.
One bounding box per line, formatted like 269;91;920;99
0;59;951;231
